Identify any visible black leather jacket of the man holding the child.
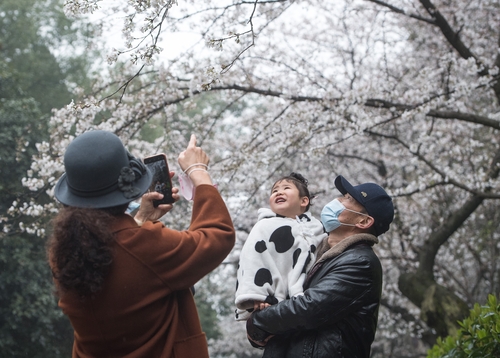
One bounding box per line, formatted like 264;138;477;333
247;234;382;358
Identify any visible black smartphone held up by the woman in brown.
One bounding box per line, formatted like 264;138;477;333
144;153;175;207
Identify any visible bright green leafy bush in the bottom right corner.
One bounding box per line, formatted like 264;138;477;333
427;295;500;358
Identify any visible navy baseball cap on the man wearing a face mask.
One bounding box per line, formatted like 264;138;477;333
335;175;394;236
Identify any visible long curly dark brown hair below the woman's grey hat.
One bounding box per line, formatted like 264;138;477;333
47;204;128;299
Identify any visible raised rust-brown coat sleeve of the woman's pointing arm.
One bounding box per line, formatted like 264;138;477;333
118;185;235;291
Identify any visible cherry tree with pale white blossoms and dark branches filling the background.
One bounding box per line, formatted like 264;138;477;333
5;0;500;357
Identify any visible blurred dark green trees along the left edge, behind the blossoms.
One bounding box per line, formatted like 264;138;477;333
0;0;98;358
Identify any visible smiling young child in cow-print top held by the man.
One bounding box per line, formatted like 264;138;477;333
235;173;327;321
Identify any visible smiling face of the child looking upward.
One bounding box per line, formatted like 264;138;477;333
269;180;309;218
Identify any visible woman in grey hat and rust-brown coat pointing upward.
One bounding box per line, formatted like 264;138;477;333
48;131;235;358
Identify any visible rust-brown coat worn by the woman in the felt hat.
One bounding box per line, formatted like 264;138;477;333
55;185;235;358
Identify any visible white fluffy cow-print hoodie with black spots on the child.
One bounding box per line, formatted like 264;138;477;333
235;208;327;321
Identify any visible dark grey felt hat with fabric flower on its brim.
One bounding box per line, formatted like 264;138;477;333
55;130;153;209
